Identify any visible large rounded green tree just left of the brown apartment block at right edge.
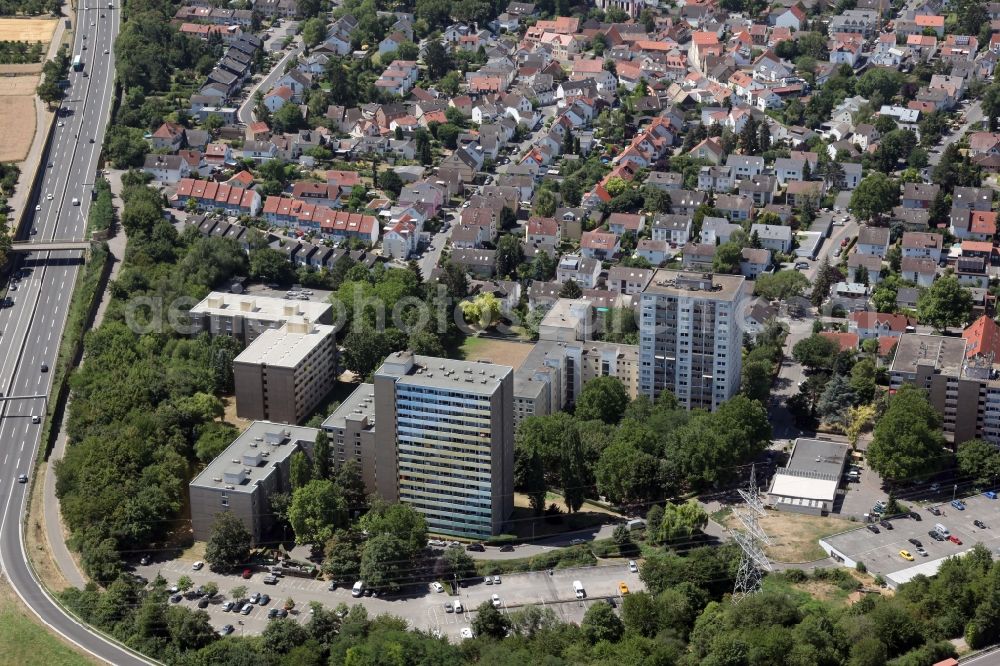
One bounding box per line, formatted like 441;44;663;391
868;384;945;480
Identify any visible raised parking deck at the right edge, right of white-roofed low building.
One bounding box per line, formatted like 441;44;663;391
821;495;1000;584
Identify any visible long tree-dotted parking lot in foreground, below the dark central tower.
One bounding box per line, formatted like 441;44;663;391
136;560;645;639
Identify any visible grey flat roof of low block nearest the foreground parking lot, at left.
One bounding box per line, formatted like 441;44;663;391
190;421;319;493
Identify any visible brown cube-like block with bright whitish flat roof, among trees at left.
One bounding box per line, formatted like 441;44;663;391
233;319;337;423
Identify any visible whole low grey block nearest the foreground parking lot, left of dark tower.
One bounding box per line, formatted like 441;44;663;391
188;421;319;544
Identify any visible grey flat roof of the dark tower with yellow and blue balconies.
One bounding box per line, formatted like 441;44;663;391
376;351;514;395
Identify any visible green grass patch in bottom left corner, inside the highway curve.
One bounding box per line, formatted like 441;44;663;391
0;582;100;666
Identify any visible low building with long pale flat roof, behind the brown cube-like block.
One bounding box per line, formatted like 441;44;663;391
190;291;333;345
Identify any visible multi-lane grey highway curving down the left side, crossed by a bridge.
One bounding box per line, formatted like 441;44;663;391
0;0;151;666
